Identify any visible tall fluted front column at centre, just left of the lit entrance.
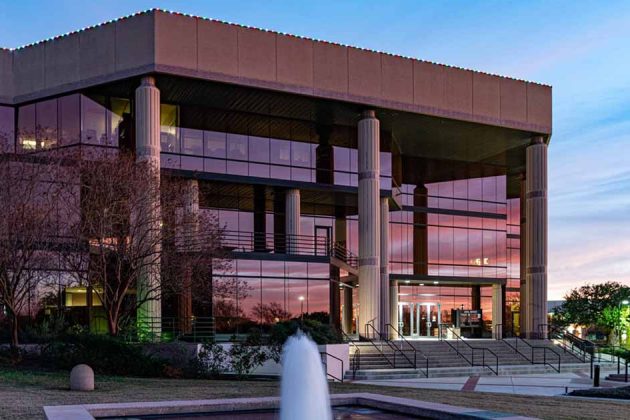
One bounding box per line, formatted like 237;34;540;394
358;111;381;335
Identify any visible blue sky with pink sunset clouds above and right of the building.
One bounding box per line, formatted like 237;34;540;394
0;0;630;299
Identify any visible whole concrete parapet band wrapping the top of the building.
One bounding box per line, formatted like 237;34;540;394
0;10;551;134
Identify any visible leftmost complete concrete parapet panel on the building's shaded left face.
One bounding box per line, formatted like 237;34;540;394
13;45;46;95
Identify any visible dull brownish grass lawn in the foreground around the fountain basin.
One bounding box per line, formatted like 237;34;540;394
0;368;630;419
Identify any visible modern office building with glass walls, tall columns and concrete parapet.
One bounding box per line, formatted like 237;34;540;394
0;10;551;337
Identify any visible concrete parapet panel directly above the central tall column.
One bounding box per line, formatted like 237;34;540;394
348;48;382;98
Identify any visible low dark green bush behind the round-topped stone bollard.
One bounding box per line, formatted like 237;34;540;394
42;333;168;377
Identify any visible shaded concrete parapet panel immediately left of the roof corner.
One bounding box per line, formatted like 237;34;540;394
116;13;155;71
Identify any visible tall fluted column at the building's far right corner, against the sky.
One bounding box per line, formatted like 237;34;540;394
525;137;547;338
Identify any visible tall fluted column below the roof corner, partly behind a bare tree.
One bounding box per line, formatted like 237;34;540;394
135;76;162;338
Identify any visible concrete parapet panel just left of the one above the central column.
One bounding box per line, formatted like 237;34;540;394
313;42;348;94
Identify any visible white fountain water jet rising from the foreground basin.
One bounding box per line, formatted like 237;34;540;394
280;331;332;420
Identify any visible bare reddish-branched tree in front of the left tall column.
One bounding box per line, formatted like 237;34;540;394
64;154;228;335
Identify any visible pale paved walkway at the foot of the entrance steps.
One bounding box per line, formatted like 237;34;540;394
355;371;627;396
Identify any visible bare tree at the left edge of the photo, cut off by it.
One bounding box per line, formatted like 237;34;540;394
0;153;63;348
